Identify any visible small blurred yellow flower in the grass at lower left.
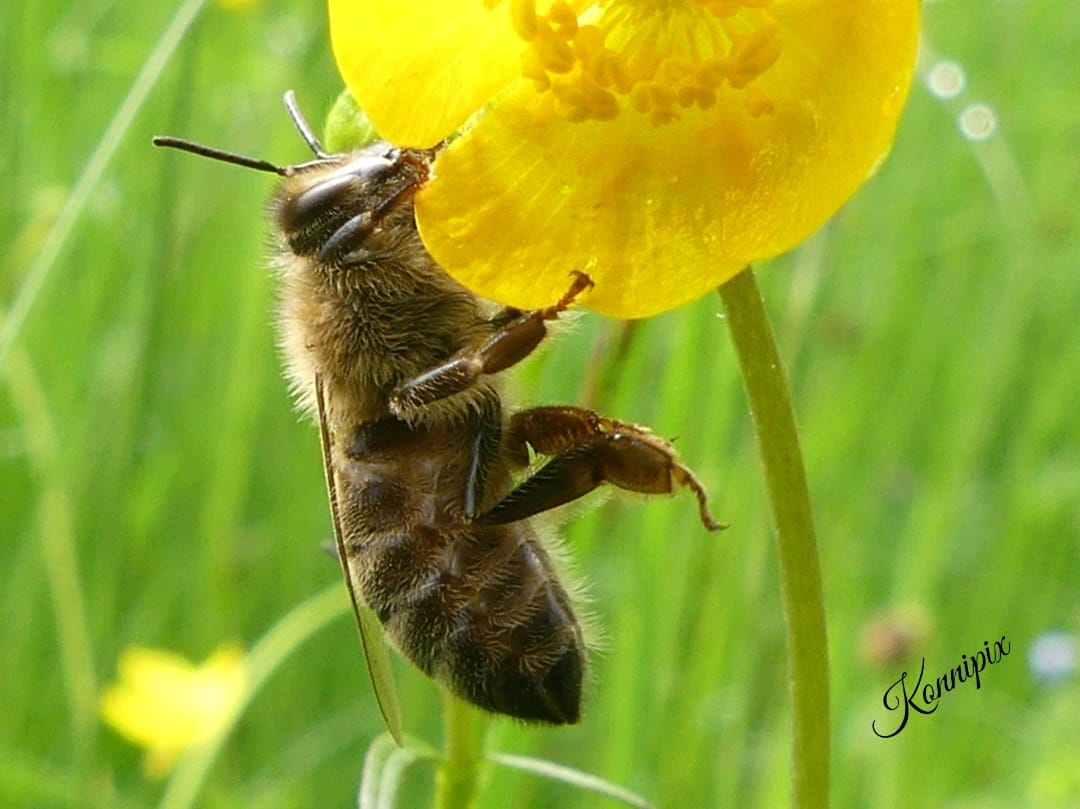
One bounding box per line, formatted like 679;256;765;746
100;646;247;778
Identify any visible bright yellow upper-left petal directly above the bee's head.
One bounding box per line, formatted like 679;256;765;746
329;0;521;147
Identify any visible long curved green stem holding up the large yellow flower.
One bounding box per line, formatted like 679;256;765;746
719;268;829;809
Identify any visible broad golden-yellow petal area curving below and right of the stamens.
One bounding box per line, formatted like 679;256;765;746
417;0;918;318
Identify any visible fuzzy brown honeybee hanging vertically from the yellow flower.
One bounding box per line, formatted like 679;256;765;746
154;93;721;725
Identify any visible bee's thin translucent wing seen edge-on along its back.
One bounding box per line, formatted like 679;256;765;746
315;376;405;747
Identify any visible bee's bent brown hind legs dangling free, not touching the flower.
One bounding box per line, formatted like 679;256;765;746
476;407;724;530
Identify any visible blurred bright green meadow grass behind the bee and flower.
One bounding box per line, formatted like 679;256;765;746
0;0;1080;809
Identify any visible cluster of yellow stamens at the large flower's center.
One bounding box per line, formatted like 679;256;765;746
501;0;782;125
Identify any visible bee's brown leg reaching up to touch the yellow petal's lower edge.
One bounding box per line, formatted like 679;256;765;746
390;272;593;417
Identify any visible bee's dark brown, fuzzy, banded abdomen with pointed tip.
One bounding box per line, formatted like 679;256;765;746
338;447;585;724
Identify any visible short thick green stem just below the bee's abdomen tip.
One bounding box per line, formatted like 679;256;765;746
435;689;489;809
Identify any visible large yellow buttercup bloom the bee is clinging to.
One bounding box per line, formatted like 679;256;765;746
329;0;919;318
